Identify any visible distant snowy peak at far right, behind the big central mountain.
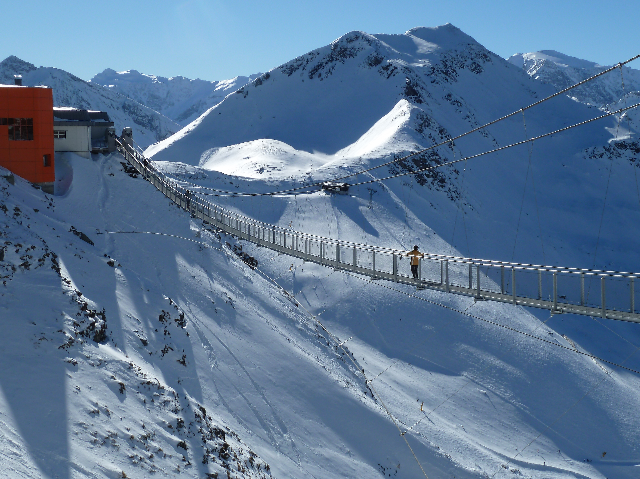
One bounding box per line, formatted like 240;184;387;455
509;50;640;107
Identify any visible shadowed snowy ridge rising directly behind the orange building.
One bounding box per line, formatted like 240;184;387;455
0;56;181;147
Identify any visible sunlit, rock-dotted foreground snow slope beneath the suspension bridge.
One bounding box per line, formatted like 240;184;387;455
0;141;640;478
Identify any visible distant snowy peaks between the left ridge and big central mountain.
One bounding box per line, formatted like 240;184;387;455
91;68;259;126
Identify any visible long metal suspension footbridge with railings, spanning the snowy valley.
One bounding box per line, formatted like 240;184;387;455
117;140;640;322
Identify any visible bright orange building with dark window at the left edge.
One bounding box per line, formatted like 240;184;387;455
0;82;55;190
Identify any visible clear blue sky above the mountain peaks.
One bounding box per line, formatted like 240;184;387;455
5;0;640;80
